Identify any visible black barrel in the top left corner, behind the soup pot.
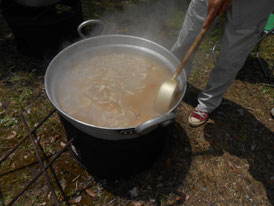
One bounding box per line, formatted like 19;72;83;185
1;0;83;57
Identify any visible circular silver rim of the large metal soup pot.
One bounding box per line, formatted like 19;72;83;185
44;34;187;131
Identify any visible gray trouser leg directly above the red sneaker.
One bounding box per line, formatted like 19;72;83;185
198;8;267;112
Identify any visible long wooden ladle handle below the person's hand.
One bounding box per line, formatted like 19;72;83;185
173;23;211;79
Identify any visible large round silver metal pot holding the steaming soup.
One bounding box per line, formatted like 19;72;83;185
45;20;187;140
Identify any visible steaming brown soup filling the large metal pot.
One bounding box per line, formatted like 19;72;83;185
57;53;169;128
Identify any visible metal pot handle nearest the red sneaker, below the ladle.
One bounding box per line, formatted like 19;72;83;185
135;112;176;134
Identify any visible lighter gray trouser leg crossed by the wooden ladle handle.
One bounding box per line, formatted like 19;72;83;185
171;0;208;78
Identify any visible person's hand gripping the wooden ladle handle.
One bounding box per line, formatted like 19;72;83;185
203;0;232;27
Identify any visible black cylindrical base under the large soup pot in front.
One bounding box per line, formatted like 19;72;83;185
59;115;167;179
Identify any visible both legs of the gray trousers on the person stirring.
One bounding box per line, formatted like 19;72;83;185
171;0;267;113
